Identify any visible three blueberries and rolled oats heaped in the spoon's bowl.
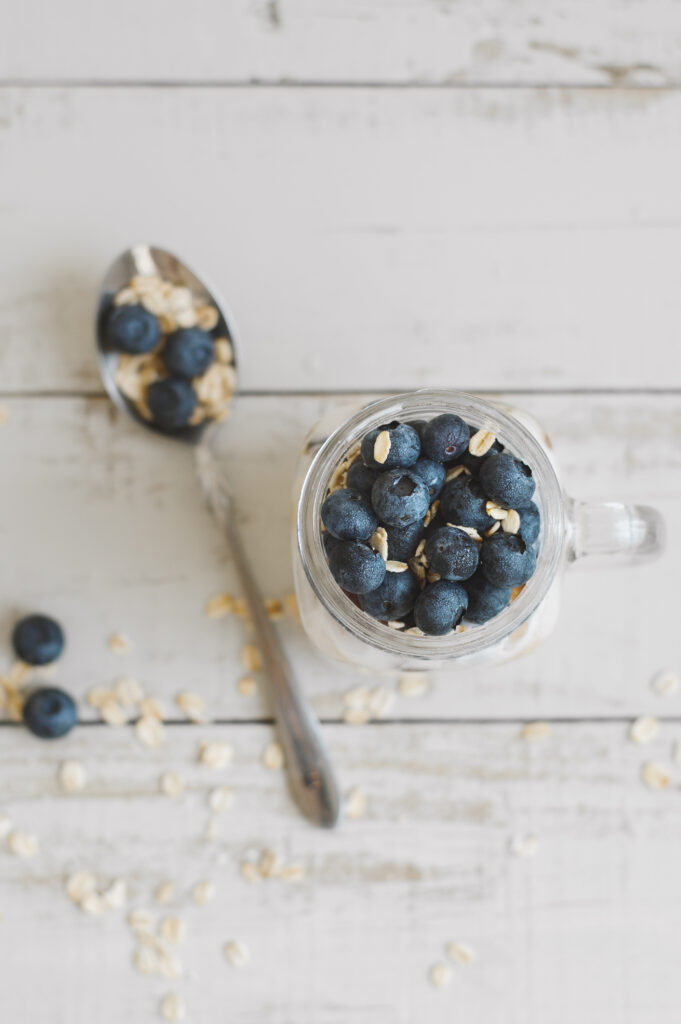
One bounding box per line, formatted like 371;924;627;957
100;279;236;433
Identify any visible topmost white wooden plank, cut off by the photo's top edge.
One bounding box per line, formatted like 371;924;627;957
0;0;681;85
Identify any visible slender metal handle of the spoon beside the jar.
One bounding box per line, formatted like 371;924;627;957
197;443;341;828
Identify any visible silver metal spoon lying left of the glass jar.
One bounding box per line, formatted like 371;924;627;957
96;245;341;828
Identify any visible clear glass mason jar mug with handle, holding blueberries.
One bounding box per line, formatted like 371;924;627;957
293;389;665;672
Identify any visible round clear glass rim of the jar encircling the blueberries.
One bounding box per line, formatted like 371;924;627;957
297;388;565;662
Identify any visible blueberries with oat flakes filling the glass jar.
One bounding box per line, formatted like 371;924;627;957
322;413;540;636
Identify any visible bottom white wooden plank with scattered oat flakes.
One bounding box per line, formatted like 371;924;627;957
0;723;681;1024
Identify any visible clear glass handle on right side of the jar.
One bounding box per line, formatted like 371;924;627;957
567;499;666;566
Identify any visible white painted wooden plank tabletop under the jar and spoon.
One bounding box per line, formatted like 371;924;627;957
0;6;681;1024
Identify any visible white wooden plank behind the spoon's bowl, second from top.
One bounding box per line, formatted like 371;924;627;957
0;88;681;391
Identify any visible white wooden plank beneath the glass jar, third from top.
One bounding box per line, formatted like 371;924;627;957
0;395;681;719
